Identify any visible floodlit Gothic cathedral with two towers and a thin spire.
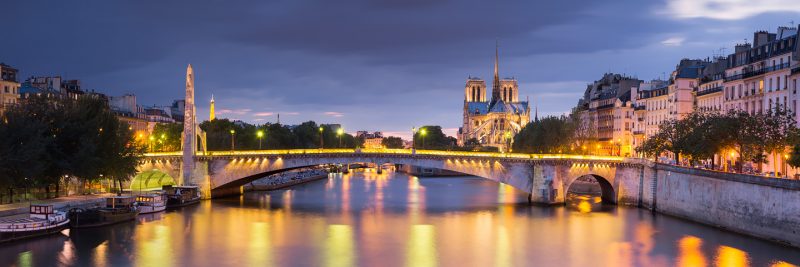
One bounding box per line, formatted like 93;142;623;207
458;48;531;151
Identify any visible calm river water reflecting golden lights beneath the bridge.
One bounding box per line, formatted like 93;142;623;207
0;172;800;266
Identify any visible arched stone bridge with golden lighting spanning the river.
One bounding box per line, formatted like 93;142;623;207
138;149;653;205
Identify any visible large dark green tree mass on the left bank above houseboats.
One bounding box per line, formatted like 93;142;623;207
0;95;143;200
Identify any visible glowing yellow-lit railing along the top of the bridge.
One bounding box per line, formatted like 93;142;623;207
145;148;625;161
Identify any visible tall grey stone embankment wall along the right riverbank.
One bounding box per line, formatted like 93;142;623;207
643;164;800;247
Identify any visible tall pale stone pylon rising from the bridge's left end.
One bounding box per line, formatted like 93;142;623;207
178;64;197;185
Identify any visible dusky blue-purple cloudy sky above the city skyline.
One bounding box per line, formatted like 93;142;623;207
0;0;800;136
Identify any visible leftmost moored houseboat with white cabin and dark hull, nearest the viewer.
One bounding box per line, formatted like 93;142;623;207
0;204;69;243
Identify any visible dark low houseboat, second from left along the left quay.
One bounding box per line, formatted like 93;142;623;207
69;196;139;228
